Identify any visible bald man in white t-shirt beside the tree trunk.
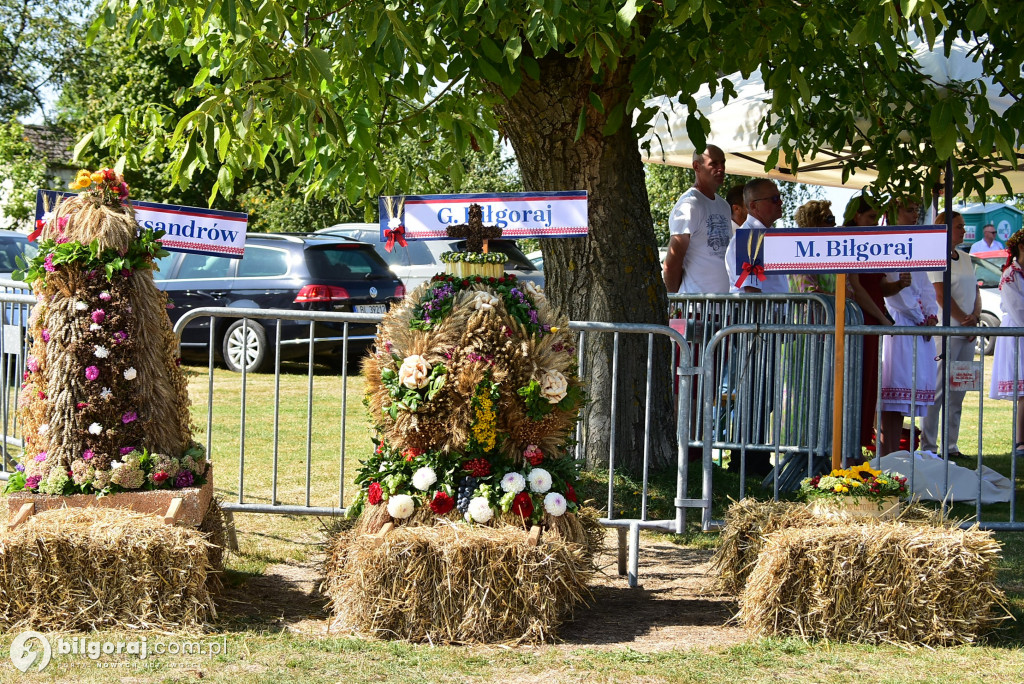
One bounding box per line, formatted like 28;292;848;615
664;144;732;294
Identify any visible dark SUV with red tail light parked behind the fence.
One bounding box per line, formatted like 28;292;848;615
154;233;406;372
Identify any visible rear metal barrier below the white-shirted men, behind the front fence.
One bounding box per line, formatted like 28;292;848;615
669;293;863;489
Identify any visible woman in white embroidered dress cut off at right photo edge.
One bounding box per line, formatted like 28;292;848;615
988;229;1024;455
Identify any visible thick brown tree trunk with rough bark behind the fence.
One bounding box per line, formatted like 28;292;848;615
497;55;676;471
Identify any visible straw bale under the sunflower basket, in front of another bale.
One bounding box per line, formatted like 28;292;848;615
738;523;1008;646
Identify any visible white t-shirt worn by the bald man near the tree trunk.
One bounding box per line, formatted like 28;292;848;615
669;187;732;293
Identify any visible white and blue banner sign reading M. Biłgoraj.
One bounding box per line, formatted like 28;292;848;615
736;225;948;273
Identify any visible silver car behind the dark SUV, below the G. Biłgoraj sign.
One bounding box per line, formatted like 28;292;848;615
316;223;544;292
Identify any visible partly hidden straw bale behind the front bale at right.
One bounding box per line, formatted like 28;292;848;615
712;499;959;595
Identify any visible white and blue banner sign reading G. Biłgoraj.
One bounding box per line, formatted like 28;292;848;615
380;190;588;242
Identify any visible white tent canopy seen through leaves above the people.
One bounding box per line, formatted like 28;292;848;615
640;41;1024;193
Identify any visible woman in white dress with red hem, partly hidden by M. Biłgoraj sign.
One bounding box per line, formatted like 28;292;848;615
881;202;939;456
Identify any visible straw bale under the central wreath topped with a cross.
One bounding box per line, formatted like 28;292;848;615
323;524;593;643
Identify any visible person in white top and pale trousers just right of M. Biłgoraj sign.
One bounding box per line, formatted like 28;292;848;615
921;212;981;458
